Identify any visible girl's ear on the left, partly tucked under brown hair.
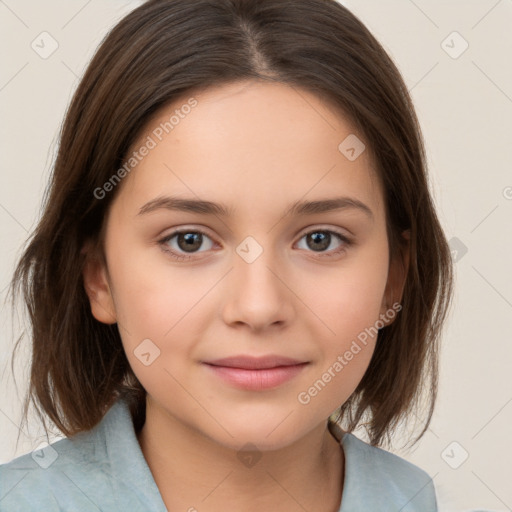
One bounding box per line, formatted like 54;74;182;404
81;241;117;324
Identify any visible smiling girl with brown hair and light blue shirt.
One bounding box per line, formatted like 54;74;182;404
0;0;452;512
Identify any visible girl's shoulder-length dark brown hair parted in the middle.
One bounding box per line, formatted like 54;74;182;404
11;0;453;445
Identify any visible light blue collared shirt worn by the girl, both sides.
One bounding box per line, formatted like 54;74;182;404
0;399;437;512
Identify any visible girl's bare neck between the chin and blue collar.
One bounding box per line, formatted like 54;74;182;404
137;401;344;512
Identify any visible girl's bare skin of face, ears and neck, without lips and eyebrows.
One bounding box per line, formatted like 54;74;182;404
84;81;407;512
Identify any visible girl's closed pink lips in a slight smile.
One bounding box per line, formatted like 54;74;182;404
203;355;309;391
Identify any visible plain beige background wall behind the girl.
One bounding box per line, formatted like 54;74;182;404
0;0;512;512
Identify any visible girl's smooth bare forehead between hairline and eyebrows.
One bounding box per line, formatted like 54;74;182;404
113;81;382;219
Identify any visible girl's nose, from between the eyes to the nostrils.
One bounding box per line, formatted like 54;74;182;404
223;240;295;331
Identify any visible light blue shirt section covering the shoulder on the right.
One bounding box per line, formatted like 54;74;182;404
340;433;438;512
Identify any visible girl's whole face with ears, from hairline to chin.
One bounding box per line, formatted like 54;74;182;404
84;81;406;450
